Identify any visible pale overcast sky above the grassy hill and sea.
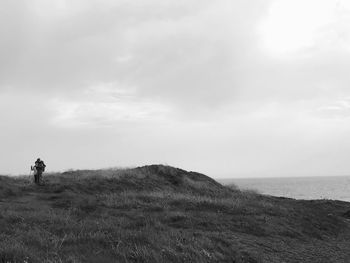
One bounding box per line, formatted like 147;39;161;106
0;0;350;178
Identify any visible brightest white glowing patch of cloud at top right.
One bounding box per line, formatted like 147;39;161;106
261;0;336;56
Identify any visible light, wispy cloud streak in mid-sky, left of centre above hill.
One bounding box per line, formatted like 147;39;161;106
48;83;169;128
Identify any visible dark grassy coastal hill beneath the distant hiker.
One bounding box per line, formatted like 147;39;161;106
0;165;350;263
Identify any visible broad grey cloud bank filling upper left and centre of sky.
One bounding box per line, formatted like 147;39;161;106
0;0;268;109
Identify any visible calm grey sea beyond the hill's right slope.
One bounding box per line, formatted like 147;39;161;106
218;176;350;202
